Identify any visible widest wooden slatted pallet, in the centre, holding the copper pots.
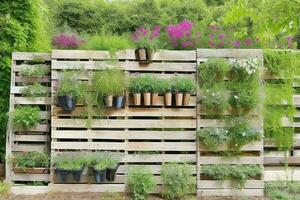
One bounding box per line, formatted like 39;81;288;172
50;50;196;192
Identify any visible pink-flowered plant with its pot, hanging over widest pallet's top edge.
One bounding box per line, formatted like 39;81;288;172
132;26;160;62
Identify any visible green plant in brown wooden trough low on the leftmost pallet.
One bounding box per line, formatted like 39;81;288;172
10;152;50;174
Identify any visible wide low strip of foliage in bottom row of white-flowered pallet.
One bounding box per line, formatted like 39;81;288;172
201;164;261;188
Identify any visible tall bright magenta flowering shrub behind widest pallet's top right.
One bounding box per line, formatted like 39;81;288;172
166;20;195;49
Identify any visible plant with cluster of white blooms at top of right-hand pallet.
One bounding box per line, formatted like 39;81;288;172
229;58;258;81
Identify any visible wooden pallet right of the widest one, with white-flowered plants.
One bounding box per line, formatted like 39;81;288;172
197;49;264;197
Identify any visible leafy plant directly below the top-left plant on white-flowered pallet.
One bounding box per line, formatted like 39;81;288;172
202;85;228;115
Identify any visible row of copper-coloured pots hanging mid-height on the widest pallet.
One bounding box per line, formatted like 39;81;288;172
133;92;191;106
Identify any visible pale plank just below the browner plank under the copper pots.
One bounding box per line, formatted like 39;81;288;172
52;119;196;128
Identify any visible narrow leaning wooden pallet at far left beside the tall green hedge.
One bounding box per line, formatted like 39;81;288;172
6;53;51;184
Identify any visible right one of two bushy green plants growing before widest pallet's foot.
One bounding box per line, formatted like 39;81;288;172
161;164;194;200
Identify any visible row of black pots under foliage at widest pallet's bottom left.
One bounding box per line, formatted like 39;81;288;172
55;166;119;183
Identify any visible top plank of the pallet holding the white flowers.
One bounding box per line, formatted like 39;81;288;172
197;49;263;58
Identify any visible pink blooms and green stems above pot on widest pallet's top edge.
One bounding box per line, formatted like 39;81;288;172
132;26;160;50
